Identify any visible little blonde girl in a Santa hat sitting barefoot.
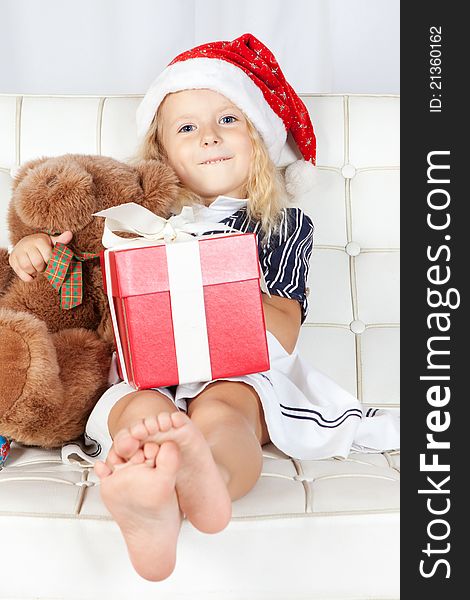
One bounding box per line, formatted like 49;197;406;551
11;34;396;581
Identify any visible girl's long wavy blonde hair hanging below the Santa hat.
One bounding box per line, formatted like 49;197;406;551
134;96;288;236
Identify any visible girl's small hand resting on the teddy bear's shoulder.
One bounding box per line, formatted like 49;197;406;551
9;231;73;281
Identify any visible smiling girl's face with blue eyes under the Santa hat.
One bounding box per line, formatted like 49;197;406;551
159;89;253;206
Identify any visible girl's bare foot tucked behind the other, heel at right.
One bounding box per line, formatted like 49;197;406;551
125;412;232;533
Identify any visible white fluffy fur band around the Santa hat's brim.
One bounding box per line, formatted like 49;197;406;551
136;58;287;165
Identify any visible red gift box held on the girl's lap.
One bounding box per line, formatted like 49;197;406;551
102;233;269;389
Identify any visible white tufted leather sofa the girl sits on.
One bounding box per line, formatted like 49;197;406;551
0;95;399;600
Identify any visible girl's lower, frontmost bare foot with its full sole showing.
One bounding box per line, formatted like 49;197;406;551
95;435;182;581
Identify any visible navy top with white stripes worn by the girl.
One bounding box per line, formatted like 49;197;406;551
206;207;314;322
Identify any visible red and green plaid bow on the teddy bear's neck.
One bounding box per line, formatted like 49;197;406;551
44;243;99;310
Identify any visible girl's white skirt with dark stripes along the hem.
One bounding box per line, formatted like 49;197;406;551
62;332;400;461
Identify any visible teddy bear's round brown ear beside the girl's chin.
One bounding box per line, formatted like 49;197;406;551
134;159;179;214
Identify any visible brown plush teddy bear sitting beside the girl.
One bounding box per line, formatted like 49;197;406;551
0;154;180;448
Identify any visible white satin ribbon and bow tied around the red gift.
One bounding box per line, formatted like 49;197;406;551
94;202;269;383
